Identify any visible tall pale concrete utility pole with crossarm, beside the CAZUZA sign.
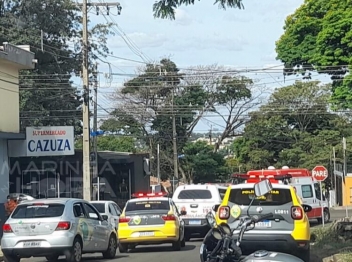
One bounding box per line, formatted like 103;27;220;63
78;0;122;201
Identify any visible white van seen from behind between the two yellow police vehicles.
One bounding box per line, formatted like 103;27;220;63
172;184;227;241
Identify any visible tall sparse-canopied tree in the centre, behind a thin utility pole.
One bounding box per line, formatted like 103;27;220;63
102;59;209;179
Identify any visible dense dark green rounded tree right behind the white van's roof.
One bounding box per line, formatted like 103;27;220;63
180;141;226;183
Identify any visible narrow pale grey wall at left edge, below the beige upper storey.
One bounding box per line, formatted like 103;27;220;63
0;139;9;205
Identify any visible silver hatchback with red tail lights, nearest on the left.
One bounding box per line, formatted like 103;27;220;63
1;198;117;262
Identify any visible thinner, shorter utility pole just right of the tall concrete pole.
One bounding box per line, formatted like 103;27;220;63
93;63;100;200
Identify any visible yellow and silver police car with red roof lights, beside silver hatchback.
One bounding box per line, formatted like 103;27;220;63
118;192;185;253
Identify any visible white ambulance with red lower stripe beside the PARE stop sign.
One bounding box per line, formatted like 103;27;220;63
290;177;330;223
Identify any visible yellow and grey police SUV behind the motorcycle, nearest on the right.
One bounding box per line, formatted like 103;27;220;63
214;176;312;262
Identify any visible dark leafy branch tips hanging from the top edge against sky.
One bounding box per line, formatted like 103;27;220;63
153;0;244;19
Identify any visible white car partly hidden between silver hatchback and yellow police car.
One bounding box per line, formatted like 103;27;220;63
90;200;122;231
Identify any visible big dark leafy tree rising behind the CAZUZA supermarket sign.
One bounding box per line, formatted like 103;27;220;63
0;0;110;132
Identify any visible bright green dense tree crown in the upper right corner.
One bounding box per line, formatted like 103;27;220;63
276;0;352;108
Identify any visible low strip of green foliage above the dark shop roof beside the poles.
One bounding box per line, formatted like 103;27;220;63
75;135;136;153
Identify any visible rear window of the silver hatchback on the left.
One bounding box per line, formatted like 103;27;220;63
11;204;65;219
